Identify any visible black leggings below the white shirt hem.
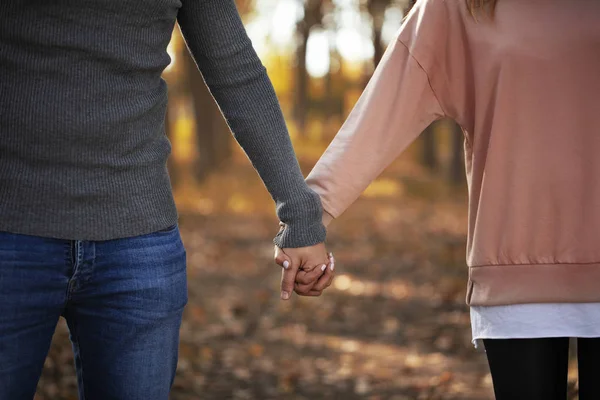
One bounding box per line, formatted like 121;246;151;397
483;338;600;400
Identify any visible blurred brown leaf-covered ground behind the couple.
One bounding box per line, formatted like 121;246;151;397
36;148;576;400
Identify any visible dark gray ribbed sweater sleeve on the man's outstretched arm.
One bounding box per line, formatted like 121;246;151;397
177;0;326;248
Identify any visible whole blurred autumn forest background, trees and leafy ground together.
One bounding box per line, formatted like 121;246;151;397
36;0;577;400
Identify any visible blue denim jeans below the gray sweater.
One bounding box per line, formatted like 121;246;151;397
0;226;187;400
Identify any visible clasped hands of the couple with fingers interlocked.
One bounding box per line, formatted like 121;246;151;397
275;243;334;300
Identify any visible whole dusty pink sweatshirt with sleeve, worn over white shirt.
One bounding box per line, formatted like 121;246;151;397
307;0;600;305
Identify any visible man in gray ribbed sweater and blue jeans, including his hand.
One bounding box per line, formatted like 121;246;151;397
0;0;332;400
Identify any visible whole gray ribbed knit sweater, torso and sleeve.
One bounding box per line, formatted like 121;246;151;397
0;0;325;247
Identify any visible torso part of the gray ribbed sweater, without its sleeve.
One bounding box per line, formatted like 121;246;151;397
0;0;181;239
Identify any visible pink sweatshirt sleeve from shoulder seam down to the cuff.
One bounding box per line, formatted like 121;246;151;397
307;38;444;218
